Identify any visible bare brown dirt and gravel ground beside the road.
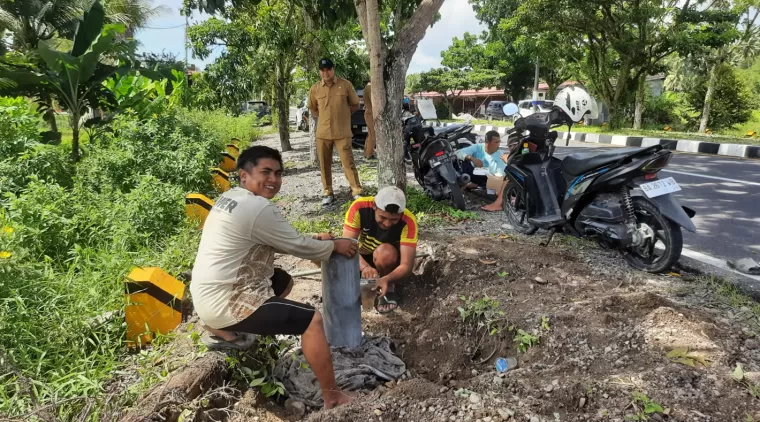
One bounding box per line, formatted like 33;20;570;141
119;132;760;422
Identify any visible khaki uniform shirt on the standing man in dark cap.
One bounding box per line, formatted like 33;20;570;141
309;76;359;140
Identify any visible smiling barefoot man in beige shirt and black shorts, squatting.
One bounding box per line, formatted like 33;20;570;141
190;146;357;409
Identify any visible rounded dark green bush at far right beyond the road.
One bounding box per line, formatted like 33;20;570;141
688;65;753;129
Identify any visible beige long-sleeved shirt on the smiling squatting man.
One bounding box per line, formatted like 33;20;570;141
190;187;334;329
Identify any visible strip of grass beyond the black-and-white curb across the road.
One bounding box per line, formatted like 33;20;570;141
441;115;760;145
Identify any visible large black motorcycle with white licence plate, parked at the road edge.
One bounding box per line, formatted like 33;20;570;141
503;106;696;272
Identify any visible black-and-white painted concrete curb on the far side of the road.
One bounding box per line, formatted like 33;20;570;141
433;122;760;159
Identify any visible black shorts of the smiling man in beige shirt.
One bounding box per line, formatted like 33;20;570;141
223;268;315;336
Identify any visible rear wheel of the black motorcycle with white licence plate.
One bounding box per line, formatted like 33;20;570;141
623;197;683;273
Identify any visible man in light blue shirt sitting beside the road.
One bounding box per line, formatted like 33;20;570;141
457;130;509;212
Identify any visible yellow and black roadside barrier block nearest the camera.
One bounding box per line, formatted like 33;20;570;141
124;267;185;347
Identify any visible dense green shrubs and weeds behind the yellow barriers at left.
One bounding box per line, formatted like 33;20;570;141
0;100;256;419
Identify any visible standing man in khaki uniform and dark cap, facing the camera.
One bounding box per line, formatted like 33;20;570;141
308;59;362;206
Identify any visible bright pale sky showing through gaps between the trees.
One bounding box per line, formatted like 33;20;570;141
136;0;485;73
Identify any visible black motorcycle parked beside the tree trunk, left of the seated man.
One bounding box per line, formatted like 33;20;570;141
402;114;470;210
